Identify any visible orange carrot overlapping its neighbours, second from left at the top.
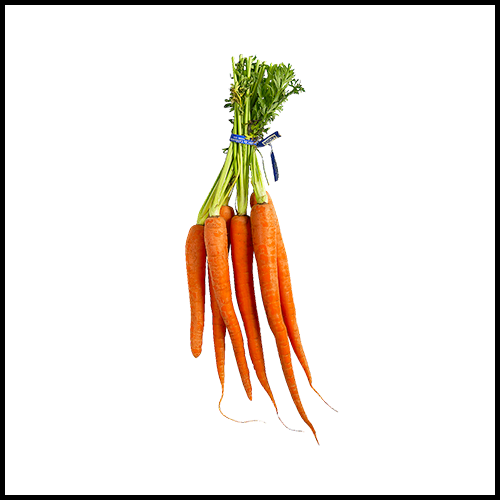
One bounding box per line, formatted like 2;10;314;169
205;216;253;401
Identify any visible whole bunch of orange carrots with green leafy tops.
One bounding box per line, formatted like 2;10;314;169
185;56;337;444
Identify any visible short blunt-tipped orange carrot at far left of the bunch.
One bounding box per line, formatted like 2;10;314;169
185;224;206;358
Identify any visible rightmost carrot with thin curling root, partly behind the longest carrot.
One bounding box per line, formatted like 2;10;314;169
250;192;338;413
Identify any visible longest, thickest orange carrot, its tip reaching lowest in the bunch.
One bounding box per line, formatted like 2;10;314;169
250;203;319;444
